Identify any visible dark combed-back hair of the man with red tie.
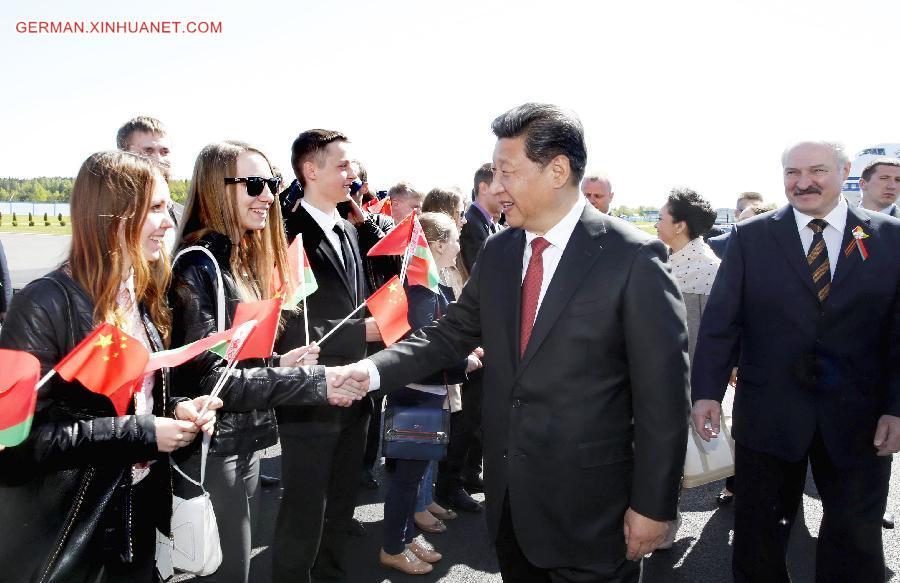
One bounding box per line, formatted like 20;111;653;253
491;103;587;186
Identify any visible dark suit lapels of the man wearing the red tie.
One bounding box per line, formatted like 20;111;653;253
515;206;606;378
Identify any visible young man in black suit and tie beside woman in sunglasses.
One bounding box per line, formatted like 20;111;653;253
272;130;381;583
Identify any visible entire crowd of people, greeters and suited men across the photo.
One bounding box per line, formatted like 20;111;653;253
0;103;900;583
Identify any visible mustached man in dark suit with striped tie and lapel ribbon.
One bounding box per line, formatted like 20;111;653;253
691;142;900;583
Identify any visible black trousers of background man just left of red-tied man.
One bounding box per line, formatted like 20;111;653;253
435;371;484;497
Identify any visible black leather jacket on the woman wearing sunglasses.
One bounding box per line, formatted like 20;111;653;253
169;232;328;455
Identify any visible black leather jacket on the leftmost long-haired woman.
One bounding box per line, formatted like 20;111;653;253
0;270;179;583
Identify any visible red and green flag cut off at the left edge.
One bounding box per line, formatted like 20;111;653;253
0;350;41;447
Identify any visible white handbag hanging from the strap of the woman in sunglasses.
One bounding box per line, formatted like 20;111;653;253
156;435;222;579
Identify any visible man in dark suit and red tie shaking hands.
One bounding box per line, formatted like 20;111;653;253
345;103;688;583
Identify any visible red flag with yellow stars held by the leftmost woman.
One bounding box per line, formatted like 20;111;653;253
53;324;150;415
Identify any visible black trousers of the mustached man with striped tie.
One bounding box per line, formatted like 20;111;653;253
732;434;891;583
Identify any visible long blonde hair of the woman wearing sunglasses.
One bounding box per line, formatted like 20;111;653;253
179;141;290;301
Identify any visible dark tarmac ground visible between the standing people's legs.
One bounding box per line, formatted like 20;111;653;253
171;418;900;583
